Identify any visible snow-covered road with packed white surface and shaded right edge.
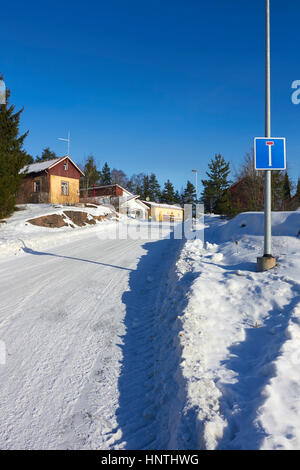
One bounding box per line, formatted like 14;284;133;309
0;229;180;449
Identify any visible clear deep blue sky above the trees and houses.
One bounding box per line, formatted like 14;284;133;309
0;0;300;193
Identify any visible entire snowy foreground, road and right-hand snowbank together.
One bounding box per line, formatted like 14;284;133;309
0;207;300;449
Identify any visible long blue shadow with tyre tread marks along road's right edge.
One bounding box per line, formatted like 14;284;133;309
108;239;181;449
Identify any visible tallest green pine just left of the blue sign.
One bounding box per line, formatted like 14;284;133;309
202;154;230;214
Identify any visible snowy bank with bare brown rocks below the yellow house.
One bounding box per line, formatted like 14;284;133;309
0;204;117;258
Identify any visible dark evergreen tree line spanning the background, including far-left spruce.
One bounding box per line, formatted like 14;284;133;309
0;74;300;219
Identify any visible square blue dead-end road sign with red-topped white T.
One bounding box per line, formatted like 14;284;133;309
254;137;286;170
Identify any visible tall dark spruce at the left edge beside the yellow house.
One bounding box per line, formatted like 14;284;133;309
0;75;30;218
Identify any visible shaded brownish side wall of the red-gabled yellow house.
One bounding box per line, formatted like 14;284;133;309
16;173;50;204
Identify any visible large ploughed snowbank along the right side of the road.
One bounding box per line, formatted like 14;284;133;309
172;212;300;449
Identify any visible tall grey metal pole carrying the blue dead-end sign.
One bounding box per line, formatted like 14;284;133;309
264;0;272;257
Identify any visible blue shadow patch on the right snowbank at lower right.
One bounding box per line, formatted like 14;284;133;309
218;287;300;450
